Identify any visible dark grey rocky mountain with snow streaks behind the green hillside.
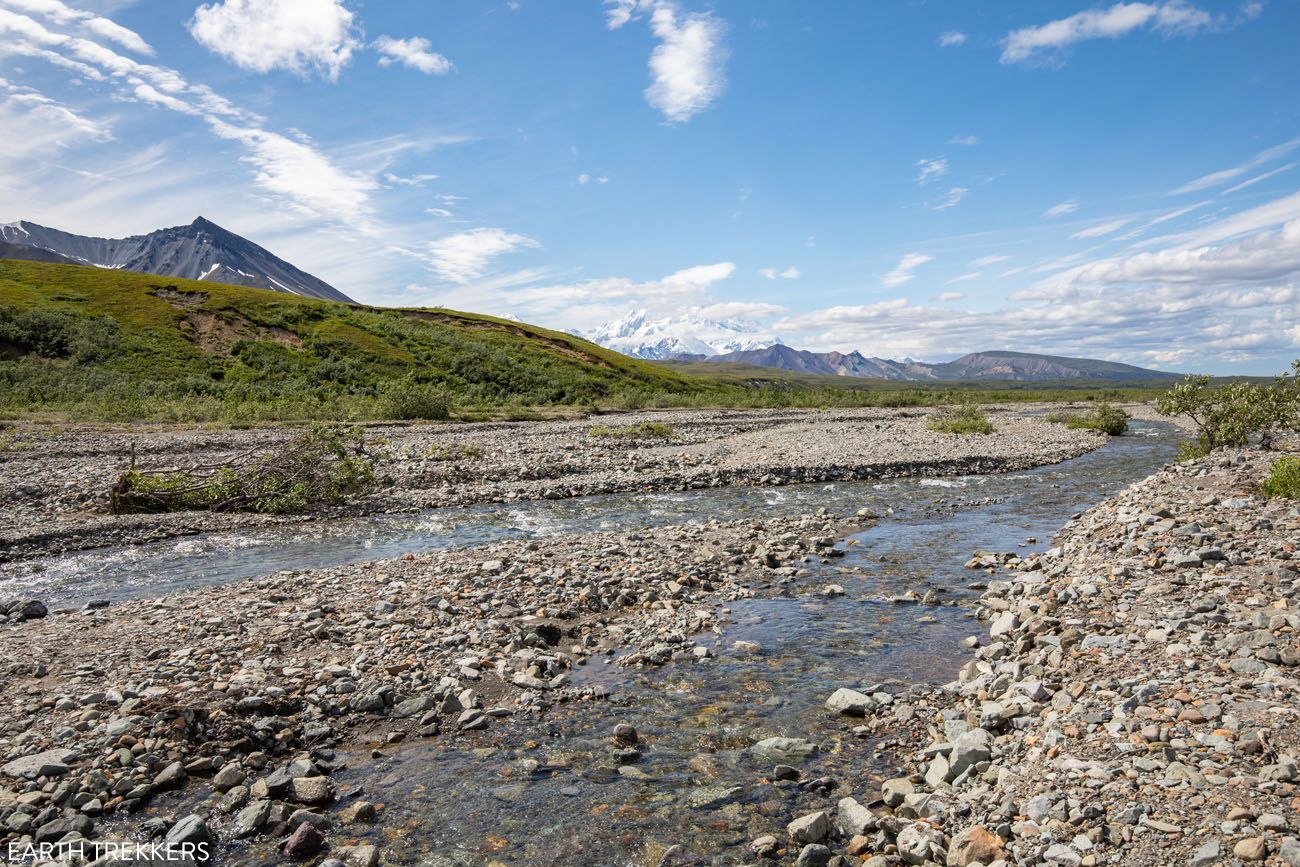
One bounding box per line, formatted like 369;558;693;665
0;217;352;303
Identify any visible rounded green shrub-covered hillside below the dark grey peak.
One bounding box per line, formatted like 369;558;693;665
0;260;716;421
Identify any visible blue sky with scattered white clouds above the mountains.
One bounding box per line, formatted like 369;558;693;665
0;0;1300;374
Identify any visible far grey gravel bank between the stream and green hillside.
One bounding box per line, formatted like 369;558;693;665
0;406;1105;562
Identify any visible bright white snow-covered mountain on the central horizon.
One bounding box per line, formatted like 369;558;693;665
582;311;781;360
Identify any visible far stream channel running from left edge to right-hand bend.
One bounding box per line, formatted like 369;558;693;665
0;424;1173;607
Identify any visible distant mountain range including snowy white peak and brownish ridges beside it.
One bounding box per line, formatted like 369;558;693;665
584;311;1178;382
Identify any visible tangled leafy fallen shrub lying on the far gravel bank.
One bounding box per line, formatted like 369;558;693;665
109;428;374;515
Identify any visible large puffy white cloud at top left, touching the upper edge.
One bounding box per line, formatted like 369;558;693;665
190;0;361;79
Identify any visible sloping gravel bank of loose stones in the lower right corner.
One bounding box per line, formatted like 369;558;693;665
790;451;1300;867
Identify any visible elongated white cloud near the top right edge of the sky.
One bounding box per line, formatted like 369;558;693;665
1001;0;1214;64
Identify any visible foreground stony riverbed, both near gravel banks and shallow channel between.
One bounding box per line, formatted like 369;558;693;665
0;410;1300;867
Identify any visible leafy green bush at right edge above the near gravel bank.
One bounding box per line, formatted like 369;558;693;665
1156;361;1300;460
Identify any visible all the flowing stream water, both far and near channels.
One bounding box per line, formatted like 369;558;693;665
10;422;1179;867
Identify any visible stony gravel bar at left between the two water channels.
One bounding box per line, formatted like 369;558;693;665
0;515;871;867
